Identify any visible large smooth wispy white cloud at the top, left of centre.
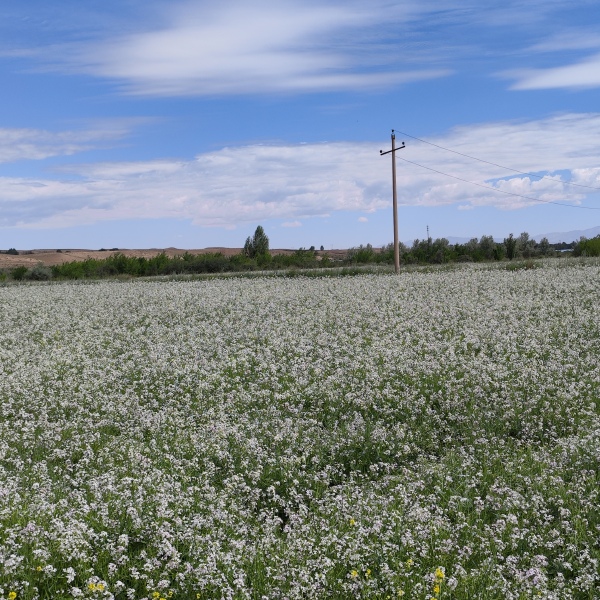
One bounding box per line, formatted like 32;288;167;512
43;0;449;96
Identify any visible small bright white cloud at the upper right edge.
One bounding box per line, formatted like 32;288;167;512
504;54;600;90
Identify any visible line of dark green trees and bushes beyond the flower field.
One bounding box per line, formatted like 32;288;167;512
0;226;600;281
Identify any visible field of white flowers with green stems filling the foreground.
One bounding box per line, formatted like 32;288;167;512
0;260;600;600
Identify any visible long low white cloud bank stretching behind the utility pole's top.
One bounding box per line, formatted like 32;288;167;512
0;114;600;228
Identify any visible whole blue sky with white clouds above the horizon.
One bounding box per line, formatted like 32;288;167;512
0;0;600;249
